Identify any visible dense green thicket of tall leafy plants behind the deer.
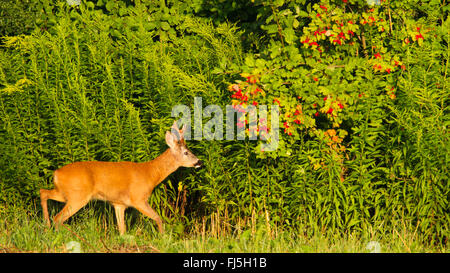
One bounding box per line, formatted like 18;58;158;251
0;0;450;243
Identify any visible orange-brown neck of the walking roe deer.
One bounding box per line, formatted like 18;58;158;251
144;148;180;187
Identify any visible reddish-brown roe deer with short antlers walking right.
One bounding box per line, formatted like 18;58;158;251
40;122;203;235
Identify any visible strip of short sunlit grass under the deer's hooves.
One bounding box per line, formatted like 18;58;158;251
0;201;449;253
